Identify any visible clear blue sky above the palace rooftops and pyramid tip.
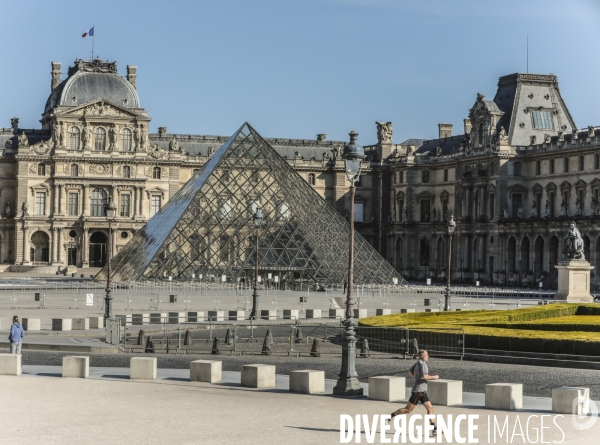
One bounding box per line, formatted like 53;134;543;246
0;0;600;145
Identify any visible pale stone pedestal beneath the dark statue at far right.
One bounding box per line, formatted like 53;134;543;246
554;260;594;303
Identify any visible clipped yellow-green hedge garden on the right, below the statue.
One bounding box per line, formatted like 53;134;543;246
359;303;600;356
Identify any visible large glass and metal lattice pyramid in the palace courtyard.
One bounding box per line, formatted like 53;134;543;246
96;123;405;285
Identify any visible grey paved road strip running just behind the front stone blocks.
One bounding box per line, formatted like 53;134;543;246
10;350;600;400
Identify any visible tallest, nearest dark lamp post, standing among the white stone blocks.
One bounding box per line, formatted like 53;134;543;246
333;131;365;396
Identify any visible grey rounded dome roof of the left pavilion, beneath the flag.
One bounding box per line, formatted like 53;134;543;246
44;59;140;113
